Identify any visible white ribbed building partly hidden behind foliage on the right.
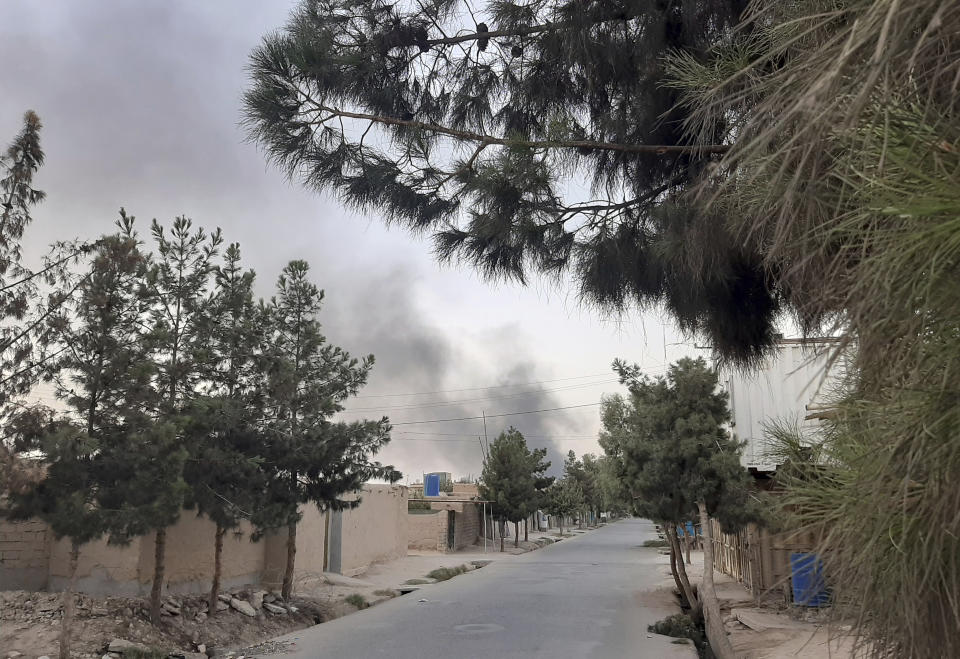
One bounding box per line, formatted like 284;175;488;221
721;339;842;471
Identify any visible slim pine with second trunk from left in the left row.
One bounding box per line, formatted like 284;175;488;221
144;217;223;623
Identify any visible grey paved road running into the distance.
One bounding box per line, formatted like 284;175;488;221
260;519;696;659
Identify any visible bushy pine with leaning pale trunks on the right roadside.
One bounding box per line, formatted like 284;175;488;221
604;358;759;657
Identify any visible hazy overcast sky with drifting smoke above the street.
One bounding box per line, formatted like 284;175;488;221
0;0;693;481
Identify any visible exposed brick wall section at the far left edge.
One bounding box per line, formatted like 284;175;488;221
0;520;52;590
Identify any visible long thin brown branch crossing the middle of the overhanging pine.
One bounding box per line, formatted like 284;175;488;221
304;105;730;155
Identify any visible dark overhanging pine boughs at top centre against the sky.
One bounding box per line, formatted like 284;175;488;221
245;0;781;361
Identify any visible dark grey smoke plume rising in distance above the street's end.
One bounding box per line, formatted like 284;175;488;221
322;268;593;480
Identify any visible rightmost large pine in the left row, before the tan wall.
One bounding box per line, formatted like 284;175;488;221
254;261;400;597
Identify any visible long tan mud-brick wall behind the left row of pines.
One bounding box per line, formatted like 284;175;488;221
0;485;409;595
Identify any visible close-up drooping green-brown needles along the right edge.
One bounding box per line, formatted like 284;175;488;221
672;0;960;658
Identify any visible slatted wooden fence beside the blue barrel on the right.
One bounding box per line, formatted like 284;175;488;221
710;520;816;601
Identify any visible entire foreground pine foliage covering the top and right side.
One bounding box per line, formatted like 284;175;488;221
244;0;960;658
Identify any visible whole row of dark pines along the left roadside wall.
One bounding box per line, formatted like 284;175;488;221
0;113;399;656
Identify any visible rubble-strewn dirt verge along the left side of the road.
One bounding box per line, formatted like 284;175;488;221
0;531;585;659
